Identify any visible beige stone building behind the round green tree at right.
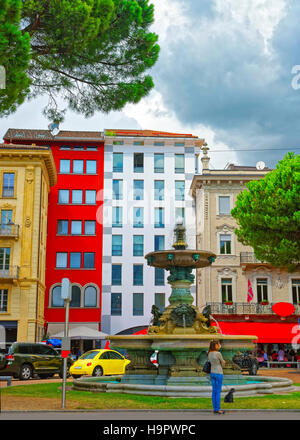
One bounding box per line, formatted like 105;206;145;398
191;147;300;348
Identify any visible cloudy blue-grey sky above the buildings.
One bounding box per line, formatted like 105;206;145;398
0;0;300;169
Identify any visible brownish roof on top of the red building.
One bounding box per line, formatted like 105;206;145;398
3;128;103;141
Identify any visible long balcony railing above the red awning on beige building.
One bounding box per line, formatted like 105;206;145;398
206;302;300;315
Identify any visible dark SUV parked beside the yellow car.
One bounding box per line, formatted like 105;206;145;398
0;342;73;380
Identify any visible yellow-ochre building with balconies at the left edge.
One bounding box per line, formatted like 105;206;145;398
0;144;57;343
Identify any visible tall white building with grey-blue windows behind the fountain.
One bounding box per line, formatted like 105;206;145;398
101;130;204;334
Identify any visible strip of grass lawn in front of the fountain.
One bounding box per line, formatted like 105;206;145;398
1;382;300;410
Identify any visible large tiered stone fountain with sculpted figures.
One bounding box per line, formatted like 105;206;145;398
74;224;293;397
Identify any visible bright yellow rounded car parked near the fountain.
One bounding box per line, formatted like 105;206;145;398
69;349;130;378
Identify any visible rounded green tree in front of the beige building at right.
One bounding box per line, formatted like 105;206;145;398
231;153;300;271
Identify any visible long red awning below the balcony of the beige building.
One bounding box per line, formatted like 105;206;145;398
214;321;300;344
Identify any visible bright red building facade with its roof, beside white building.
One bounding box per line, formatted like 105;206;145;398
4;129;104;346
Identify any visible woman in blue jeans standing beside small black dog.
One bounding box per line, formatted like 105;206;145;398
208;341;225;414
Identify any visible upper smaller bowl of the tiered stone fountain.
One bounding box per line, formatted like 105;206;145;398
145;249;216;269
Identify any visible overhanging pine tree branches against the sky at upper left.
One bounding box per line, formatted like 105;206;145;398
0;0;159;121
